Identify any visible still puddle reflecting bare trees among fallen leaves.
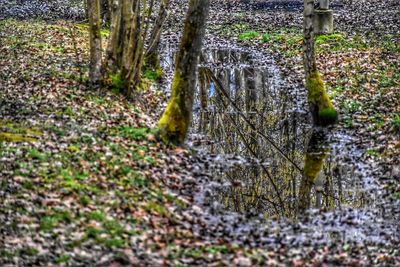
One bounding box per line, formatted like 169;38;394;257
160;44;376;218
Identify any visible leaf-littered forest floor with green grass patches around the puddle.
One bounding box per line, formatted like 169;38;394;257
0;0;400;266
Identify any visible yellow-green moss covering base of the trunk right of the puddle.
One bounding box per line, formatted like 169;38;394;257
306;71;338;126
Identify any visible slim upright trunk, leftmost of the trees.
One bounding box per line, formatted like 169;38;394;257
87;0;102;85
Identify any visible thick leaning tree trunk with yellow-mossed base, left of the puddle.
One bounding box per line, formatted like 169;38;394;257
158;0;210;145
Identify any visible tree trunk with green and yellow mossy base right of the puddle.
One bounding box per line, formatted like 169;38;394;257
303;0;338;126
